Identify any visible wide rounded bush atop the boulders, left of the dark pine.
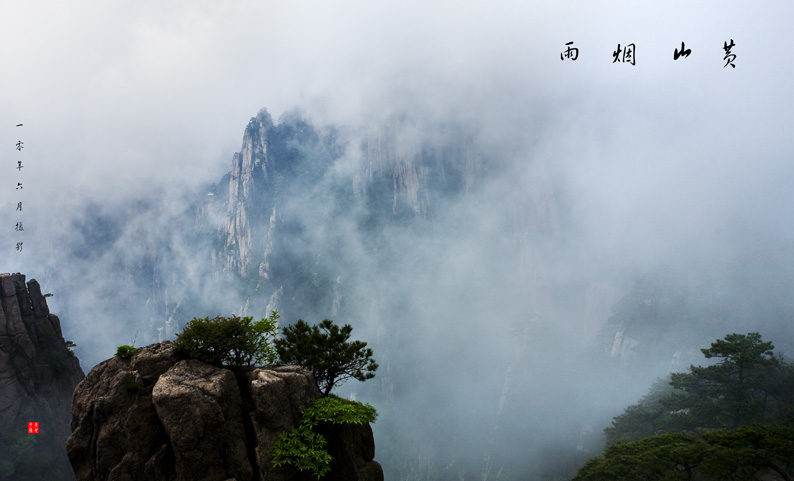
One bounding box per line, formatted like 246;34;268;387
174;311;279;366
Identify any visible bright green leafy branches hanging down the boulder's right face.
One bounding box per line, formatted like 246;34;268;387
273;396;377;479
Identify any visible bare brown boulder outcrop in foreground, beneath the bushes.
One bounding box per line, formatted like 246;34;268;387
67;341;383;481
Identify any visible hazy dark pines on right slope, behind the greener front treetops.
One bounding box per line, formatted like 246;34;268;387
604;333;794;444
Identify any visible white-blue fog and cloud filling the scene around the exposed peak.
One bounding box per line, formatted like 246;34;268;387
0;0;794;479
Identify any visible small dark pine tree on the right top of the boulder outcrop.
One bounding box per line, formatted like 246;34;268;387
275;319;378;396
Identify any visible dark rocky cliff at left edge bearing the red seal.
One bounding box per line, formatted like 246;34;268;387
0;274;85;480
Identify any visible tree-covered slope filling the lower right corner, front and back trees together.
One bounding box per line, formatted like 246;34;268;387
574;332;794;481
